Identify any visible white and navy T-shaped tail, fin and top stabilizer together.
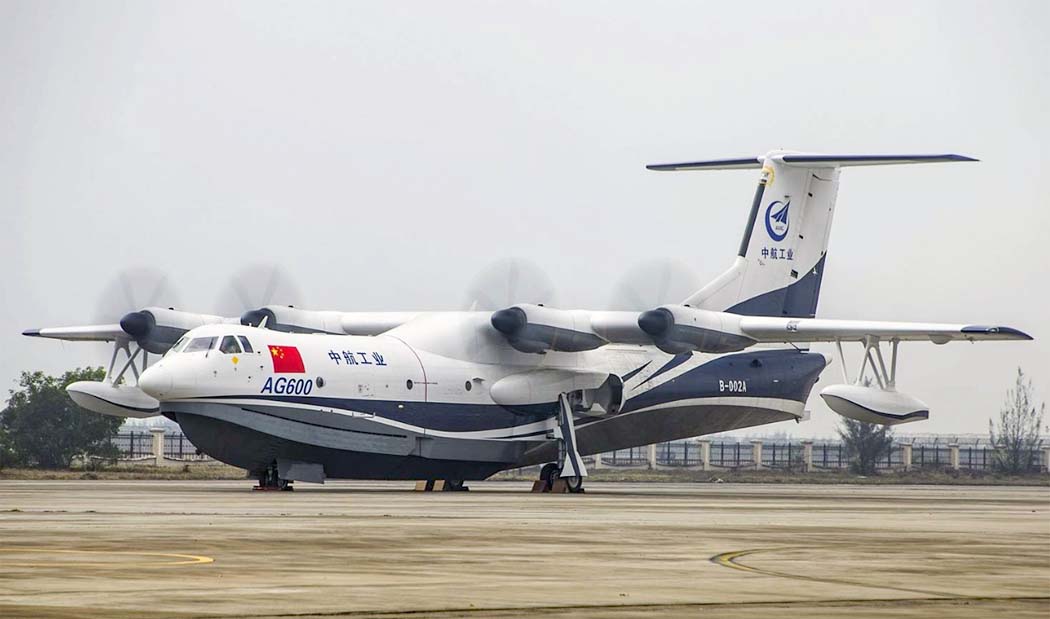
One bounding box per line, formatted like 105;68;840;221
648;151;977;318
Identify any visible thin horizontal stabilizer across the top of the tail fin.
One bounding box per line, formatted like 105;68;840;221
646;152;978;172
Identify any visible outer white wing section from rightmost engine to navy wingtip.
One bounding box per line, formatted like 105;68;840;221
740;316;1032;344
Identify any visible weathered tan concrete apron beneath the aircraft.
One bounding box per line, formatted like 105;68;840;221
0;481;1050;618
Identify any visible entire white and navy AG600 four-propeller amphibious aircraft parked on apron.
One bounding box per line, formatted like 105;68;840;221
24;151;1031;491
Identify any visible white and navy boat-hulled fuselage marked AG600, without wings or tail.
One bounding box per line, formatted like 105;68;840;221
140;313;825;478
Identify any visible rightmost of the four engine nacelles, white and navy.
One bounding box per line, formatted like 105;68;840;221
638;305;755;355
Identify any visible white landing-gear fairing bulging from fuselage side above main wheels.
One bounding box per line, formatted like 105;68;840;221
488;368;624;415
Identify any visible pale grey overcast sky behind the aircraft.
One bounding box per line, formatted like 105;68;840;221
0;0;1050;435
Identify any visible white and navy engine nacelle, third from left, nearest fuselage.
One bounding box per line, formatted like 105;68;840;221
490;304;607;354
